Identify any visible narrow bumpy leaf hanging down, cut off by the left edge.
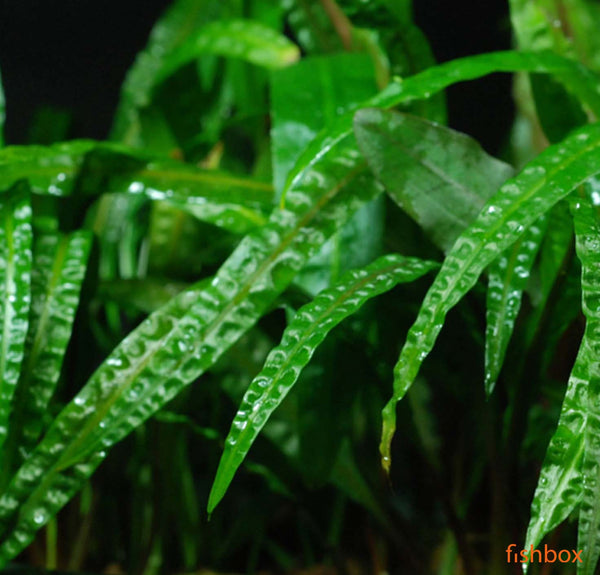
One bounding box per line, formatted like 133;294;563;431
0;184;32;454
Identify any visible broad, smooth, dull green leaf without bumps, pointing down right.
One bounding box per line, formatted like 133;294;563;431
354;109;513;252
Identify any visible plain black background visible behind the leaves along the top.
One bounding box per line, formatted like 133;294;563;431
0;0;512;152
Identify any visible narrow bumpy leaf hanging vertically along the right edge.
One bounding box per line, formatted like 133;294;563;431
568;196;600;575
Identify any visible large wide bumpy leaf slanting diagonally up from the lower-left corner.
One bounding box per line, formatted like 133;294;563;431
0;117;380;563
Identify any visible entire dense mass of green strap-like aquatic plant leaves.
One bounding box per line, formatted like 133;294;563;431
0;0;600;575
